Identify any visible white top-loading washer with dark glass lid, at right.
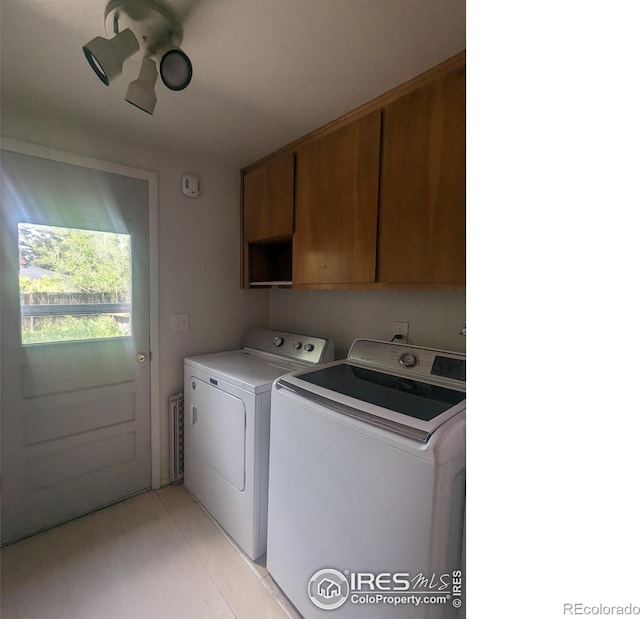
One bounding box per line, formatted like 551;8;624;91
267;340;466;619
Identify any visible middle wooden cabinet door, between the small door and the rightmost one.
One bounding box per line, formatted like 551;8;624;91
293;110;380;286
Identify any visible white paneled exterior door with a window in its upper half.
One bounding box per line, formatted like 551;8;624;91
1;151;151;543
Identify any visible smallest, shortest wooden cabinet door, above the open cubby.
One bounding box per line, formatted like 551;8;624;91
243;154;293;243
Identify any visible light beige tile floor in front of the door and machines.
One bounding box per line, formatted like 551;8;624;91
0;485;298;619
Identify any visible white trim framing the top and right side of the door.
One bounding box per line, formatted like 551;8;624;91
0;137;162;489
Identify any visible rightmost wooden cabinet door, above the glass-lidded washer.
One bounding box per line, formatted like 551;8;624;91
378;67;465;287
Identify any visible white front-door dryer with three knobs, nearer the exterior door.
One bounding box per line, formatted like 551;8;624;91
184;328;335;559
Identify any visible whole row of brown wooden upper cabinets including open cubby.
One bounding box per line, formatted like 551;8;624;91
242;52;466;290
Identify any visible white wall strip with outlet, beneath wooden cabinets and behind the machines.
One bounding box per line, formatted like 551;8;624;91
270;290;466;358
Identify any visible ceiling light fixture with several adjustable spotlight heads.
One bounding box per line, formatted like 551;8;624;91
82;0;193;114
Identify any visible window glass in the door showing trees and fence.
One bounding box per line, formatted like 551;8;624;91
18;224;131;344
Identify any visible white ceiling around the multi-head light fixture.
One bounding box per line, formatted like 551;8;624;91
0;0;465;166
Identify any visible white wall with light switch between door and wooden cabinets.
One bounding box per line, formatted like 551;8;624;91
2;105;269;484
